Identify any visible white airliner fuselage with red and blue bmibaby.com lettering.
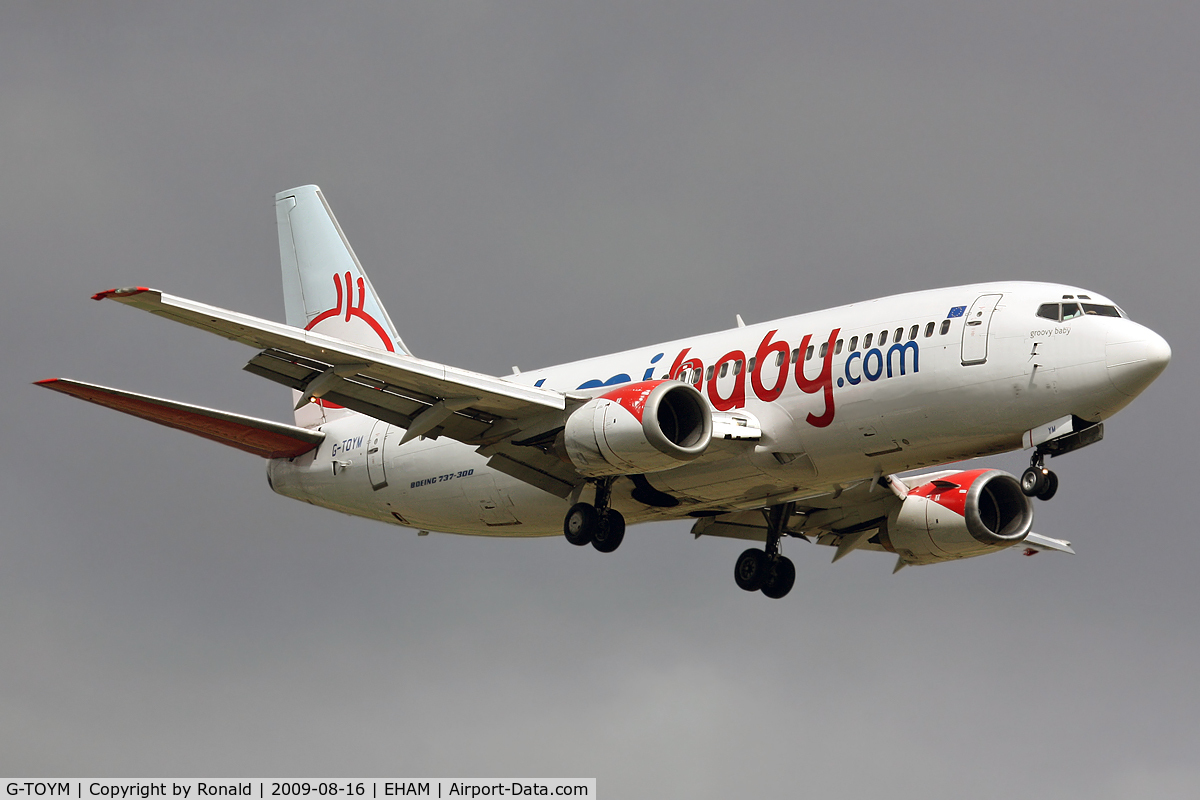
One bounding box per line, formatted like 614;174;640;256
269;282;1165;536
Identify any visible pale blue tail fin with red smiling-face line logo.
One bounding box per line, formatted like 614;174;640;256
275;186;410;427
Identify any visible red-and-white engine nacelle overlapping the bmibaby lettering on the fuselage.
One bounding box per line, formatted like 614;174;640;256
559;380;713;477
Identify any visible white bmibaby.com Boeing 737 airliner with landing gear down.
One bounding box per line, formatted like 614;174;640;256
37;186;1171;599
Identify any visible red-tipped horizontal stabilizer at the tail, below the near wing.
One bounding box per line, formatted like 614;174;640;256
36;378;325;458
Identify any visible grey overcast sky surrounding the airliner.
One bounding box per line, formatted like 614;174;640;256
0;0;1200;800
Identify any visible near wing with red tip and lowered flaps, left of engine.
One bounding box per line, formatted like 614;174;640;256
92;287;586;497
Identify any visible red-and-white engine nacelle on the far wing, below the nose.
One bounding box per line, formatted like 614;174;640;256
881;469;1033;564
